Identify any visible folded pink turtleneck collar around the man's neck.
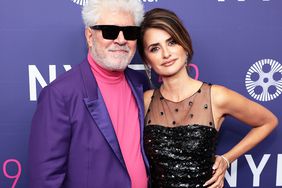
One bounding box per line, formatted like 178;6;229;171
87;52;125;84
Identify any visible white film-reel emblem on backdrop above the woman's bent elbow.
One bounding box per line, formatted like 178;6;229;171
245;59;282;101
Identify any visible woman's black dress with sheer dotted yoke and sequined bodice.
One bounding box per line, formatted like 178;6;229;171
144;83;217;188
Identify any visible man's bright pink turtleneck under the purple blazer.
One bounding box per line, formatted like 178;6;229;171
88;53;147;188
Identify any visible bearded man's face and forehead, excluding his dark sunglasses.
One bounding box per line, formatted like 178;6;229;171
85;11;136;71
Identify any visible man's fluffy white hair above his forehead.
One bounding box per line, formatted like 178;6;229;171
82;0;144;27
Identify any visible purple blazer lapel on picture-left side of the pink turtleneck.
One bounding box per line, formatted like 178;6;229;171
80;59;126;169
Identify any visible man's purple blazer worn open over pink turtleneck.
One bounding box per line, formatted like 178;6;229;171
28;60;148;188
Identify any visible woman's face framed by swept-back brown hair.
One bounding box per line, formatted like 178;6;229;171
143;28;187;76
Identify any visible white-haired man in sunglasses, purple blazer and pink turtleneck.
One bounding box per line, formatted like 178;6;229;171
29;0;227;188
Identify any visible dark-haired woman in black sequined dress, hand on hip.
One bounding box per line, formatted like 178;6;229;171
138;9;278;187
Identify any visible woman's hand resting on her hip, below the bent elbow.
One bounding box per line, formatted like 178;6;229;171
204;155;227;188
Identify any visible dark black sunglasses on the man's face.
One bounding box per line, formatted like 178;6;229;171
90;25;140;40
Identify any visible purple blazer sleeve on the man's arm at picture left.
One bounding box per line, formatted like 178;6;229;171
28;85;71;188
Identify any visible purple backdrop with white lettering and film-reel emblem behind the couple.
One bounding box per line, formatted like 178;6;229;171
0;0;282;188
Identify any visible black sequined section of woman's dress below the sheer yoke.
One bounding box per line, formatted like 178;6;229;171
144;125;217;188
